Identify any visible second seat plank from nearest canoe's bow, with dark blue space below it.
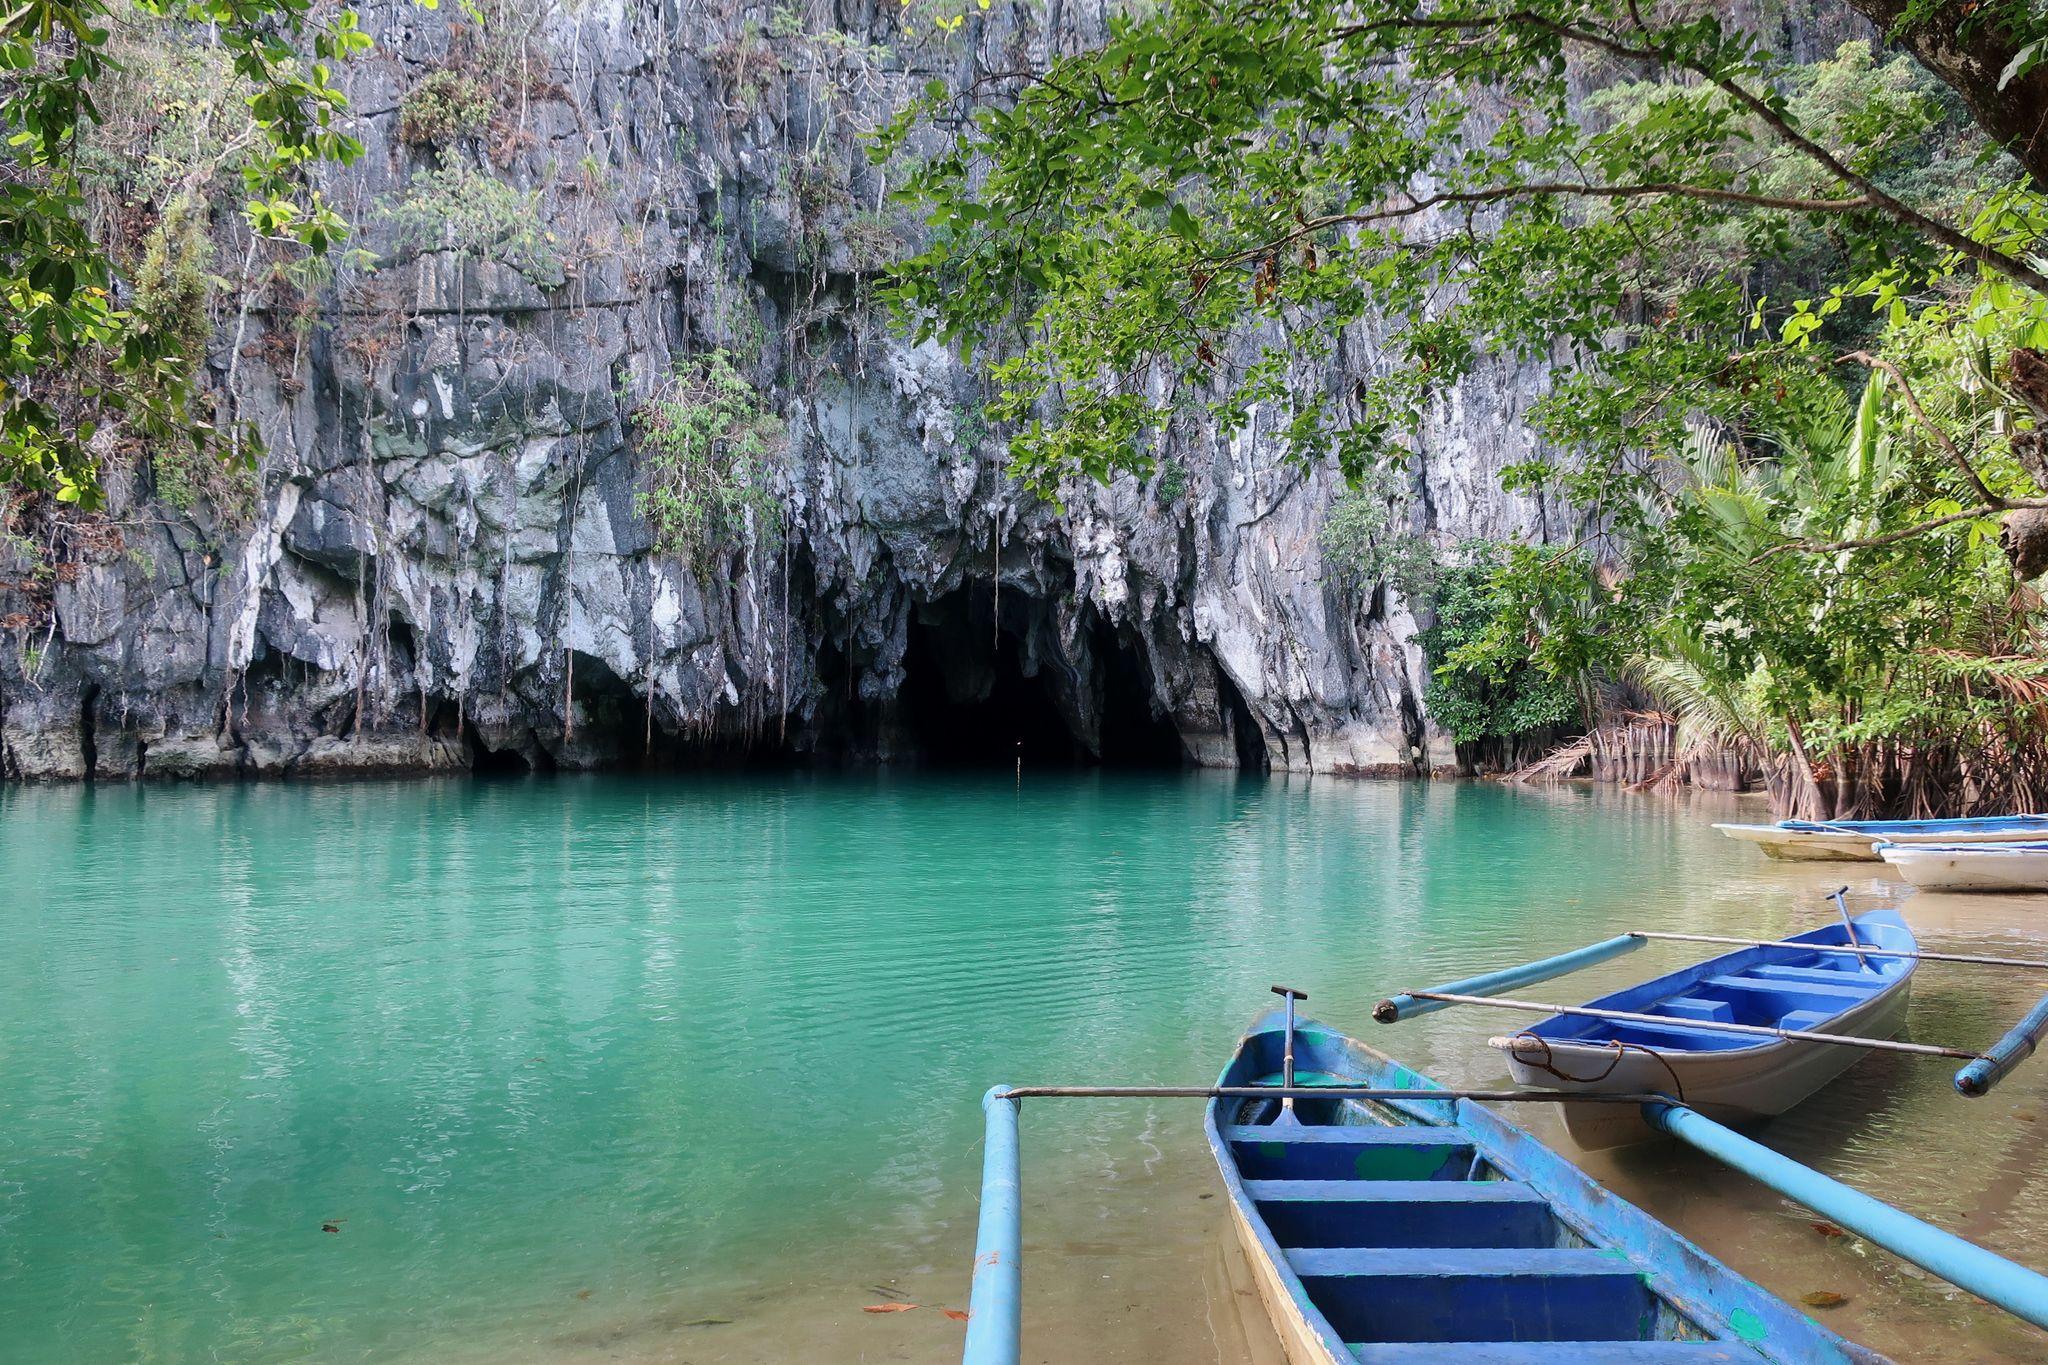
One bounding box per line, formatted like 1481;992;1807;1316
1245;1181;1561;1246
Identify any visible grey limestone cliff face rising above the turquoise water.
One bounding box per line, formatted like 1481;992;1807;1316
0;0;1577;780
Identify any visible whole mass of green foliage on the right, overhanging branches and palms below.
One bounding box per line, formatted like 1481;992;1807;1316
895;0;2048;806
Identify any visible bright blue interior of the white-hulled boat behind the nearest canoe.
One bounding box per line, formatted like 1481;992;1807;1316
1526;917;1913;1052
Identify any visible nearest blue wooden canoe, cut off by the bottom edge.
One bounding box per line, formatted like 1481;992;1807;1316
1196;1011;1884;1365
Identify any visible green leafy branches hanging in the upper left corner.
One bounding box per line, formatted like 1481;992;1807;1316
0;0;369;505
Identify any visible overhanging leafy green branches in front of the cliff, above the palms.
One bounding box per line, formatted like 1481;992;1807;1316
883;0;2042;501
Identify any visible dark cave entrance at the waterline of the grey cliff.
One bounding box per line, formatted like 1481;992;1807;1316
897;583;1188;767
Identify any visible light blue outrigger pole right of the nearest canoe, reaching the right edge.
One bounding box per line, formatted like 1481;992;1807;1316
1642;1105;2048;1326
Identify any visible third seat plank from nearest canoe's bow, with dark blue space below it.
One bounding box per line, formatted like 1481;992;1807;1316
1286;1246;1663;1342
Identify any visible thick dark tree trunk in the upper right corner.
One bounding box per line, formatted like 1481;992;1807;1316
1849;0;2048;188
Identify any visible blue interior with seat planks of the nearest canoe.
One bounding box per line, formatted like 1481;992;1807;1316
1212;1031;1761;1365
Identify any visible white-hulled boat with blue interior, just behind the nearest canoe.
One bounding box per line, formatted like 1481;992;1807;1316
1489;911;1917;1150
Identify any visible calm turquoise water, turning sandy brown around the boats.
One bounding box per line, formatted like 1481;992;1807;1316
0;774;2048;1361
